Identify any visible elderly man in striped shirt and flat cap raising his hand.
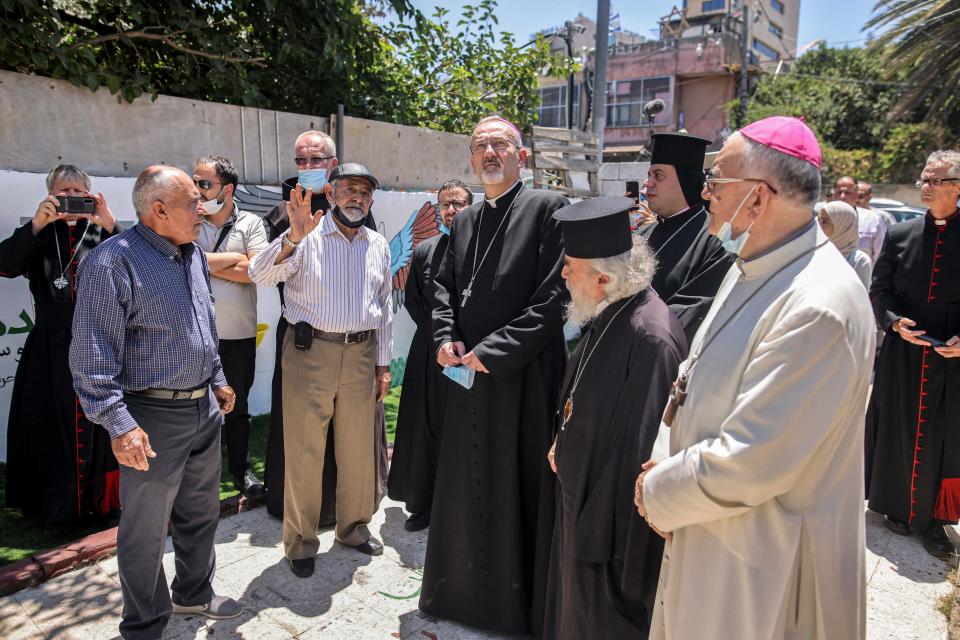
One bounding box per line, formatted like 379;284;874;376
250;163;393;578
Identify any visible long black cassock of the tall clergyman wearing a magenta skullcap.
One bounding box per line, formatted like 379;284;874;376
420;183;569;633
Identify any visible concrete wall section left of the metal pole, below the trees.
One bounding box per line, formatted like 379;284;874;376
0;71;329;184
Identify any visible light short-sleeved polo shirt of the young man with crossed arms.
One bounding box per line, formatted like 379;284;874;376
197;205;267;340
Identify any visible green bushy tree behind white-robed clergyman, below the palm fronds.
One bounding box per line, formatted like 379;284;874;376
744;45;958;184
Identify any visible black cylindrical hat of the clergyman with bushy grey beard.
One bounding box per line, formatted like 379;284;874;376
553;198;636;259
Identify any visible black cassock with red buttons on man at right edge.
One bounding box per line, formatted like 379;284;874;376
866;213;960;531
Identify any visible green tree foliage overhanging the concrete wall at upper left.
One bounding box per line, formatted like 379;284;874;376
0;0;550;132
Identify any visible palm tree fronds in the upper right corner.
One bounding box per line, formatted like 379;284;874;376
864;0;960;126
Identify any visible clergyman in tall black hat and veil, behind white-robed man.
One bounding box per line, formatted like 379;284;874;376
640;133;734;342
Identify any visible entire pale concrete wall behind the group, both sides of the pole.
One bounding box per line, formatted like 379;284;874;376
0;71;476;189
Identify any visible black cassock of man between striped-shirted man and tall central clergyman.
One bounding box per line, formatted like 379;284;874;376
387;234;453;513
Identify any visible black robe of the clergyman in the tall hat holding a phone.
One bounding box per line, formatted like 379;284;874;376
640;203;734;342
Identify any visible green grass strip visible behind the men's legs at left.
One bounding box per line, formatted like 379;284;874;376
0;386;400;565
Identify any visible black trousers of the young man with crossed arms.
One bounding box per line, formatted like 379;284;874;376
220;338;257;482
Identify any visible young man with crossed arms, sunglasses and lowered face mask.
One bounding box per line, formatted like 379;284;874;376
193;156;267;498
